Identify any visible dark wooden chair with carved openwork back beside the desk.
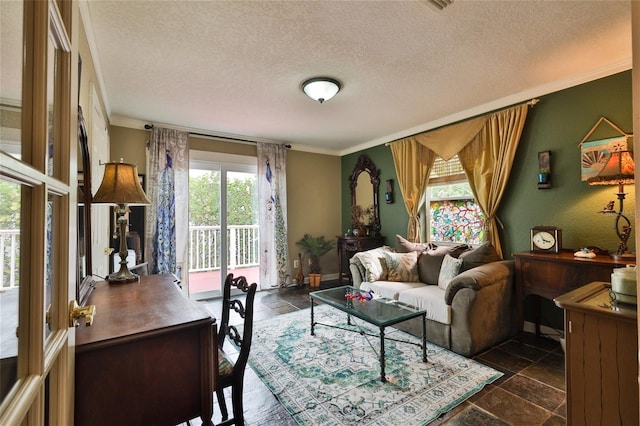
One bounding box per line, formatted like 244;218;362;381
216;274;258;425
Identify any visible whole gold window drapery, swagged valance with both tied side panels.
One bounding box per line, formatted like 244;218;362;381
390;104;528;251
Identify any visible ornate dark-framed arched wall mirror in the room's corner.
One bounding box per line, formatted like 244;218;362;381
349;154;380;237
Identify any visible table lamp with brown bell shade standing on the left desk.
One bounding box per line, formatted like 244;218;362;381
91;159;151;284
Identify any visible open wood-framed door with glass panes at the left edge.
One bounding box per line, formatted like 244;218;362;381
0;0;78;425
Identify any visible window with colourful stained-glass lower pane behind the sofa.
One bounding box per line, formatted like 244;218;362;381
426;155;485;245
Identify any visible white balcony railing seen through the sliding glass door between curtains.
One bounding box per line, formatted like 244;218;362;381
189;225;260;272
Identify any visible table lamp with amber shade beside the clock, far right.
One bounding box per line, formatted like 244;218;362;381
587;151;636;260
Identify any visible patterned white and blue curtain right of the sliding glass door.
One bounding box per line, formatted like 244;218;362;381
258;143;292;288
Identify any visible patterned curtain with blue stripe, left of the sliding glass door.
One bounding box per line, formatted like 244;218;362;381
144;127;189;276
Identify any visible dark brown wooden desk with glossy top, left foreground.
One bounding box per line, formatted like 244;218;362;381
75;274;217;425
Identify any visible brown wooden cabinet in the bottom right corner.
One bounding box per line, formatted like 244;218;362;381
555;282;638;425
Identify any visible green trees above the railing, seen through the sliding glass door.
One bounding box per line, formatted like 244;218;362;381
189;170;258;226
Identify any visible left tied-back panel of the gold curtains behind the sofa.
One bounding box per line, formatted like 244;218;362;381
391;137;436;241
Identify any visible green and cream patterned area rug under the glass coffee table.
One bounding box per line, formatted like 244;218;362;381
249;305;502;426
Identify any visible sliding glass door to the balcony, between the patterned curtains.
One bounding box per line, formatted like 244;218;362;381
188;150;260;300
